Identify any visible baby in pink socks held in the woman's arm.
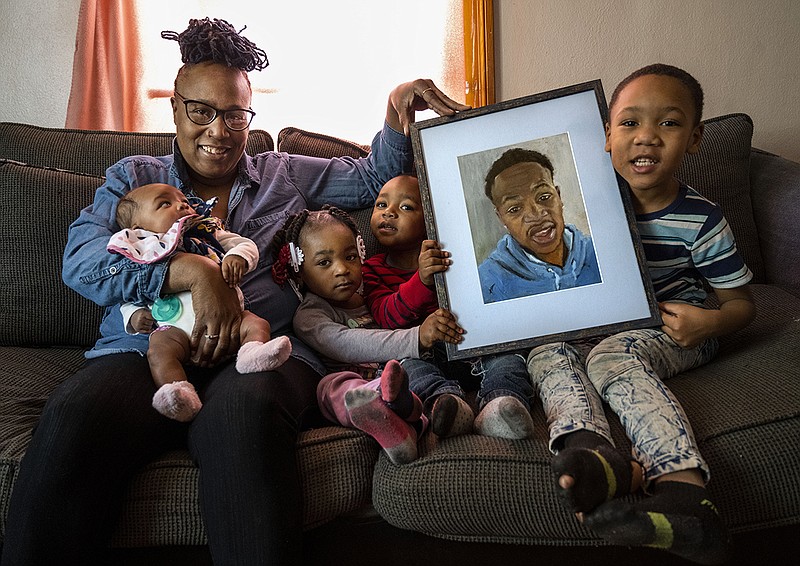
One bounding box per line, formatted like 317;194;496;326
108;184;292;422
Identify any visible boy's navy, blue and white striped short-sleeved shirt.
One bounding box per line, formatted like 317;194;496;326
636;184;753;304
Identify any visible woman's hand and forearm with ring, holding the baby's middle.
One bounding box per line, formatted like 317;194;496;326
162;253;242;367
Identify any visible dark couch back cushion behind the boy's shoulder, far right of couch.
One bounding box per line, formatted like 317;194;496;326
677;114;764;283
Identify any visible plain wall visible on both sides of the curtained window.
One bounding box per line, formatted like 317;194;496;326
0;0;800;161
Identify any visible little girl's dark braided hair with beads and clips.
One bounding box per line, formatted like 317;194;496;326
271;204;361;287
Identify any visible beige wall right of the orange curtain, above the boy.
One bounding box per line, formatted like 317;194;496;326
494;0;800;161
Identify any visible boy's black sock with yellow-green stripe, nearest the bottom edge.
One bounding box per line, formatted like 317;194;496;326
584;481;731;564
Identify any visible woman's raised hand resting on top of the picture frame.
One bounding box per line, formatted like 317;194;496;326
386;79;470;135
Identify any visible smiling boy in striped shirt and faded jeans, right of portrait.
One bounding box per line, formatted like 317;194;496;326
528;64;755;564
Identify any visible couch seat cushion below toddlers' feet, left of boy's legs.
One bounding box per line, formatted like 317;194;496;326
373;418;598;544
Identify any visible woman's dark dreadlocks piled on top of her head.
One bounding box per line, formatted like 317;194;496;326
161;18;269;72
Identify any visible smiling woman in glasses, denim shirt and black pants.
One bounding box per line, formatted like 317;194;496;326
2;19;466;566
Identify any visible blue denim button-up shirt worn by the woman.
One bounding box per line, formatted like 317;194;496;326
62;124;413;373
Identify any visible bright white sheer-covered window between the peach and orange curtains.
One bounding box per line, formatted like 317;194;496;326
137;0;465;143
